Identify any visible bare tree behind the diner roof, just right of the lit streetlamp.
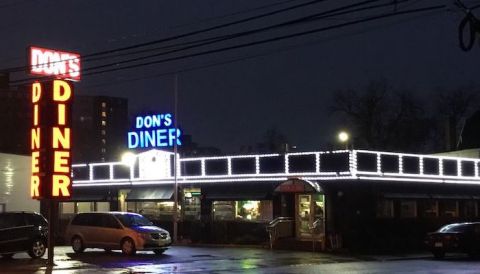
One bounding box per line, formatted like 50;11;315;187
332;80;430;152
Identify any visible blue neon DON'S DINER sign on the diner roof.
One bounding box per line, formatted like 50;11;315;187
128;113;182;148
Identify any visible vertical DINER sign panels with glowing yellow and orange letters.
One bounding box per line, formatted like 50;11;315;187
30;80;73;199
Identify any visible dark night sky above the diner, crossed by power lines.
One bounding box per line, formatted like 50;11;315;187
0;0;480;152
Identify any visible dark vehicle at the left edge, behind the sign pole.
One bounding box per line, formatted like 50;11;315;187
0;212;48;258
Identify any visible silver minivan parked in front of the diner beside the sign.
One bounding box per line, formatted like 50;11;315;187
65;212;172;255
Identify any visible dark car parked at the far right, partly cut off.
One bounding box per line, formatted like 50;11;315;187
425;222;480;258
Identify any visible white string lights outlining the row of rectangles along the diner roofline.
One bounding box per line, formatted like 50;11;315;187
72;150;480;187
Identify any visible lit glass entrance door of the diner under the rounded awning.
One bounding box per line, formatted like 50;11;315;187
295;193;325;241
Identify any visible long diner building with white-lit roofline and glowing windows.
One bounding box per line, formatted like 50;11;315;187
64;150;480;249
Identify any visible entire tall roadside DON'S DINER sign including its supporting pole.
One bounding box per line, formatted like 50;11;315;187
28;47;80;270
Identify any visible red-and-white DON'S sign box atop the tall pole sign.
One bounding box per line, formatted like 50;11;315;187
28;47;80;81
